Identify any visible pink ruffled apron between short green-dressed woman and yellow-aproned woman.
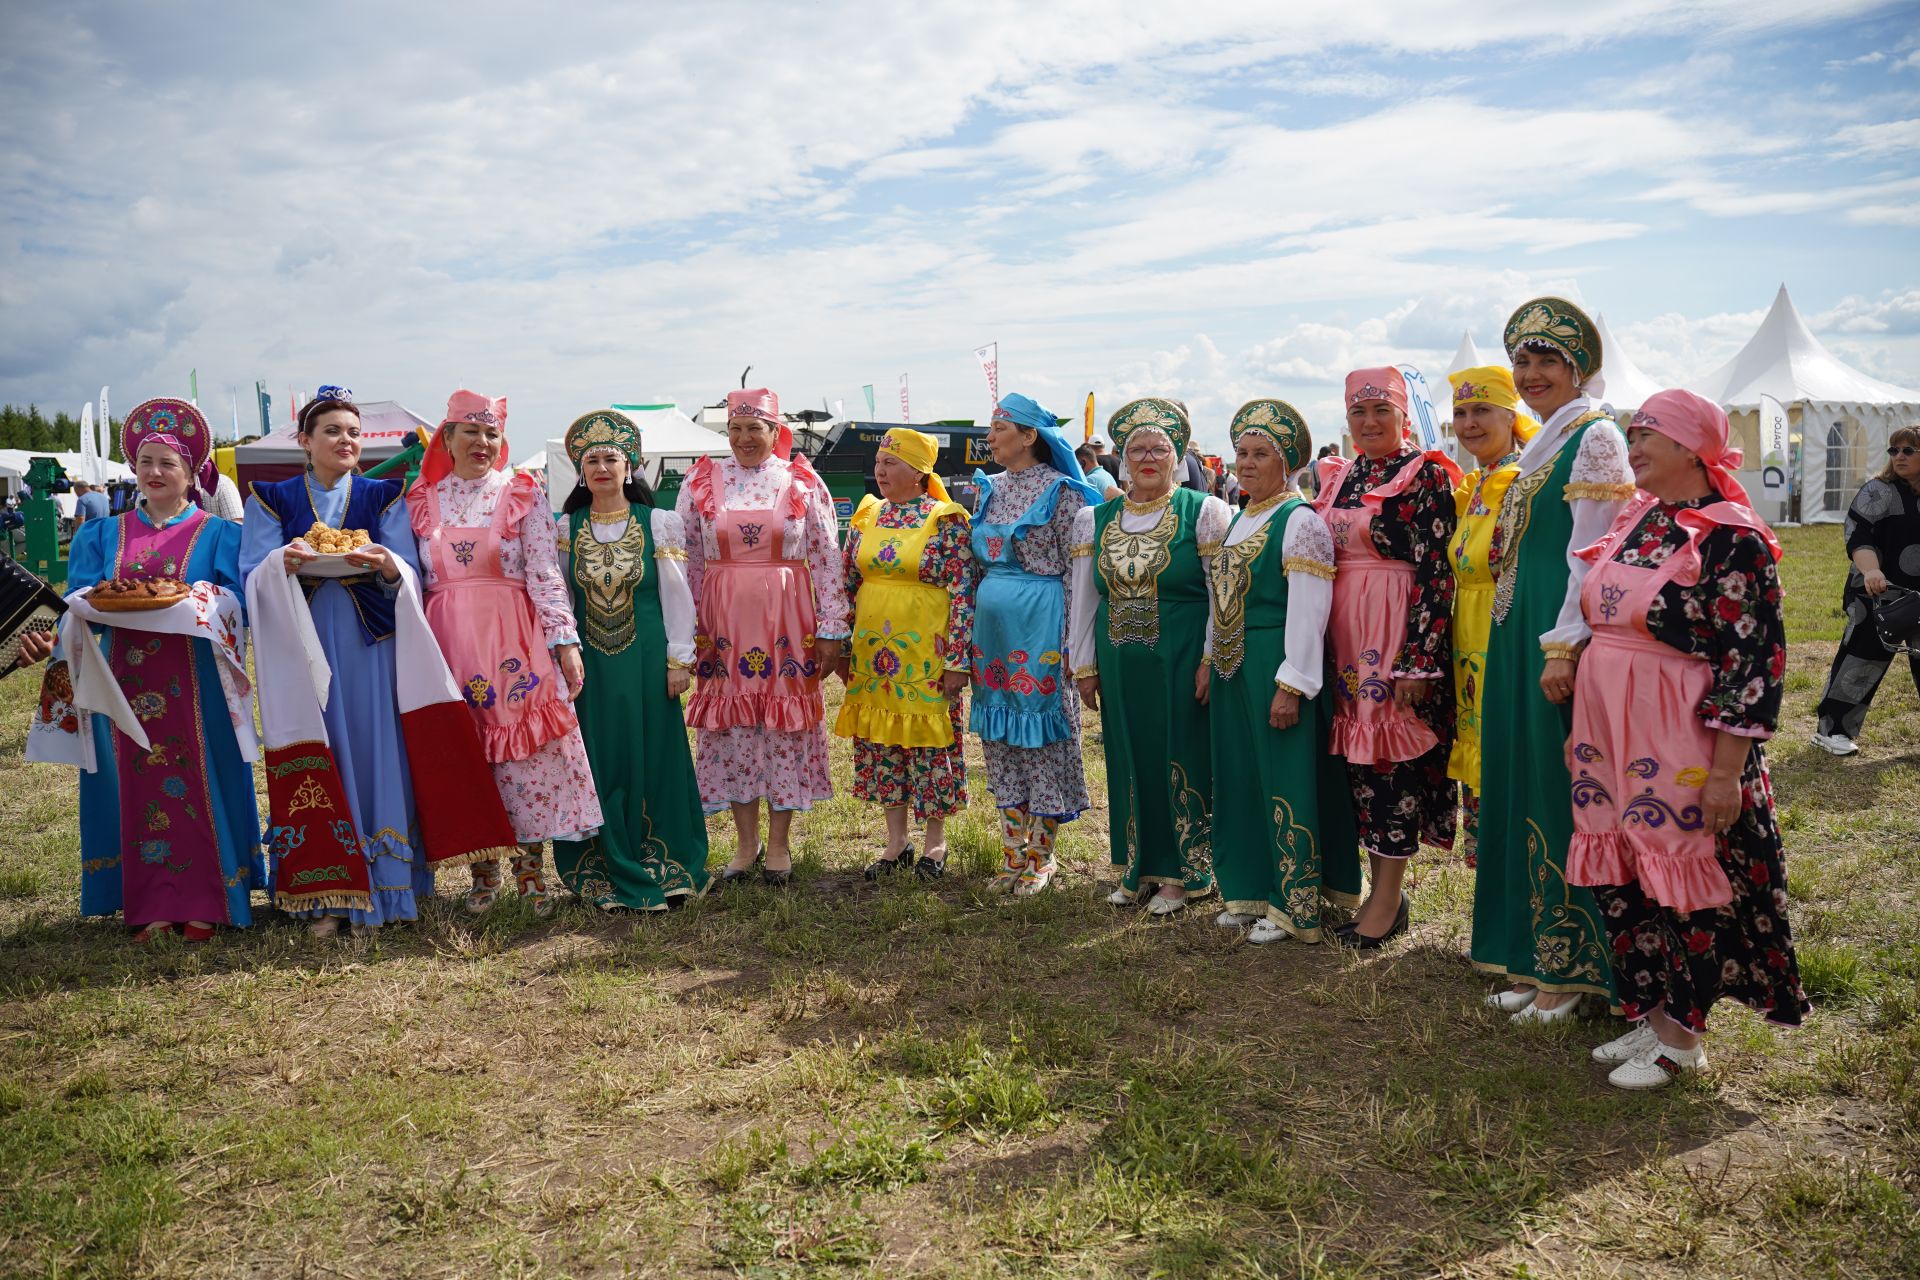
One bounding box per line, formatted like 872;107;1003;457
1315;453;1440;764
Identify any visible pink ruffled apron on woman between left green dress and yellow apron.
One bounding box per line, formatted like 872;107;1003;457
687;474;826;733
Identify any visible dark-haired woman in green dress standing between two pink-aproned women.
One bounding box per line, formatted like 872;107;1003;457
553;409;707;912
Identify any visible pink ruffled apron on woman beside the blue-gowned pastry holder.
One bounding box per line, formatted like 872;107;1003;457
426;477;578;764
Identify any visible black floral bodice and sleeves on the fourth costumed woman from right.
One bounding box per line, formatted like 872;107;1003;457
1332;447;1457;679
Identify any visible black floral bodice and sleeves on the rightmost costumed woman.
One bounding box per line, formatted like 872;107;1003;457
1613;497;1788;737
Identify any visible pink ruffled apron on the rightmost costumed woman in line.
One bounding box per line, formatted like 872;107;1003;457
1567;499;1734;912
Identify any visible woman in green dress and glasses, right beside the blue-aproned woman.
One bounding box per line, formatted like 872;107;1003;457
1068;399;1233;915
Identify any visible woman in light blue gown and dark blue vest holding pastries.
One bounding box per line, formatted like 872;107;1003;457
240;386;434;936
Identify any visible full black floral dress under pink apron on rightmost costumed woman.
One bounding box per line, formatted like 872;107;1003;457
1594;499;1811;1031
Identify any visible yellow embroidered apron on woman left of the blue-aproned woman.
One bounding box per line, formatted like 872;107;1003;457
833;501;966;747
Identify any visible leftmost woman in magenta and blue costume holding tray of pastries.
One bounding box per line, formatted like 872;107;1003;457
67;399;259;942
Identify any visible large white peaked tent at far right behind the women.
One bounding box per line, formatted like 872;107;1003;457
1690;284;1920;524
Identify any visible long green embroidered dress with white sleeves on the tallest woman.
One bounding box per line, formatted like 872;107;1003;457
1471;401;1632;1002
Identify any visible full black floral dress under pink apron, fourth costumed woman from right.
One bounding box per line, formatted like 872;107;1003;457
1332;449;1459;858
